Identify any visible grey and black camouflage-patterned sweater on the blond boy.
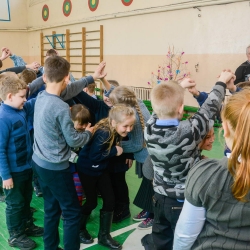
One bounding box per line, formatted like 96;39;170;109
144;82;226;199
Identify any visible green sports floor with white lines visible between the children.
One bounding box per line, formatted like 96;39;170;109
0;128;224;250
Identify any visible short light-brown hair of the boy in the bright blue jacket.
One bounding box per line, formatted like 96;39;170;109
0;74;27;101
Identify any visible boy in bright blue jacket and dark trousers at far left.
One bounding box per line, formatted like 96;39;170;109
0;73;43;249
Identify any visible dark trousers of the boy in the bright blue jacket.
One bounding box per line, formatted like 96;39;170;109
4;169;33;234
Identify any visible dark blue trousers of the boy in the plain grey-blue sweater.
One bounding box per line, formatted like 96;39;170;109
32;161;81;250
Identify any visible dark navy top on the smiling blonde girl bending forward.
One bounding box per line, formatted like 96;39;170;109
77;129;117;176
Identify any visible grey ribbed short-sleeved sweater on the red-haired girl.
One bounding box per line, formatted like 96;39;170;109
185;157;250;250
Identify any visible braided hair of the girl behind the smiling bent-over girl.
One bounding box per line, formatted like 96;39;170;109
109;86;145;130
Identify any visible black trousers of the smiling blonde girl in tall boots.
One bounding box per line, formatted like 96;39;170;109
78;171;115;215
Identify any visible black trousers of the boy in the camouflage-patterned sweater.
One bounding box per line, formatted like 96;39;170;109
152;193;183;250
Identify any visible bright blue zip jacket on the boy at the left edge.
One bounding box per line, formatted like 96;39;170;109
0;99;36;180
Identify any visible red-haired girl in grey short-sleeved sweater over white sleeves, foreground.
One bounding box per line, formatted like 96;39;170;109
174;88;250;250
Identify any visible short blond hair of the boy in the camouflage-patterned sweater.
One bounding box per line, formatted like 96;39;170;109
150;81;184;118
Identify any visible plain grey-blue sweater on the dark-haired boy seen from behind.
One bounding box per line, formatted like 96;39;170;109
32;76;93;170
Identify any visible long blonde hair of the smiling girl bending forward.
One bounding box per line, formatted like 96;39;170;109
93;105;135;154
